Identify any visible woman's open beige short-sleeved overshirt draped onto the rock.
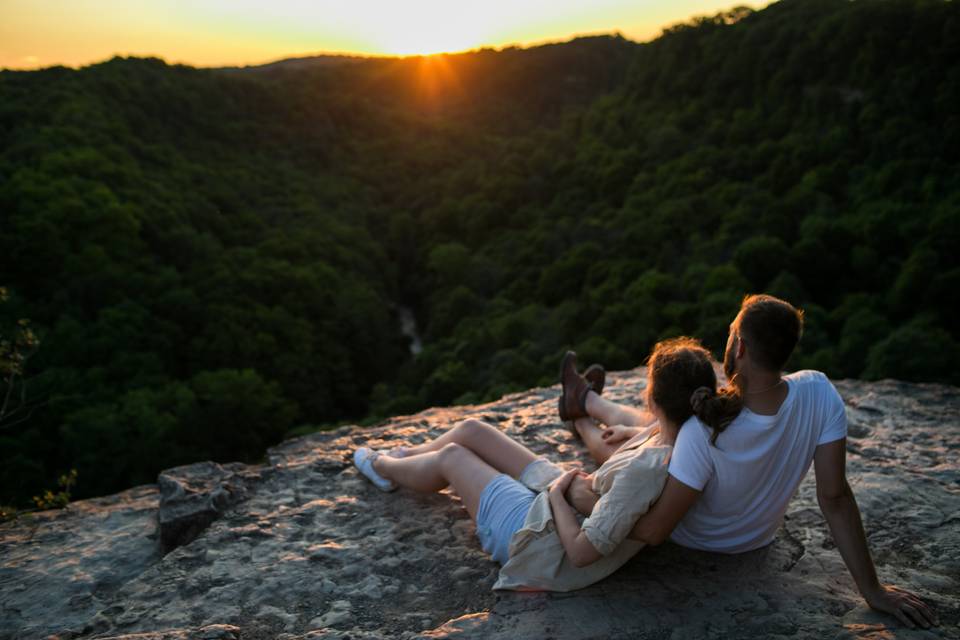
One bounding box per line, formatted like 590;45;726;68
493;427;673;591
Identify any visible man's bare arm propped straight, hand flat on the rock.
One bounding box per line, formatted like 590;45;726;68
813;438;937;628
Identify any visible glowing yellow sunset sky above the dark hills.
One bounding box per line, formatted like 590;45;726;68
0;0;765;69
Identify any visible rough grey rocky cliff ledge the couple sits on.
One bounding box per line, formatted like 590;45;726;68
0;370;960;640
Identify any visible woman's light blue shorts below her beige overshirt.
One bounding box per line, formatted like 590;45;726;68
477;473;537;564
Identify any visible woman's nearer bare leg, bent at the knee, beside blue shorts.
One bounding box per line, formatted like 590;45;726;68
373;442;499;522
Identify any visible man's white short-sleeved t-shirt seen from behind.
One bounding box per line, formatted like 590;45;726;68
669;371;847;553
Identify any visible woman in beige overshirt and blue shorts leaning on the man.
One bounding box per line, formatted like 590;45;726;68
354;338;729;591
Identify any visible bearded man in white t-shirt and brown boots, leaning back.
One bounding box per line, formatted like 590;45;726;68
560;295;937;628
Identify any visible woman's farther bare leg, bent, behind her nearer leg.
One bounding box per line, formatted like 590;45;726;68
401;418;537;478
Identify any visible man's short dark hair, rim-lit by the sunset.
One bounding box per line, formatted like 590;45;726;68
737;294;803;371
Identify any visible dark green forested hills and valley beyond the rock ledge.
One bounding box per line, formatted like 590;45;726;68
0;0;960;504
